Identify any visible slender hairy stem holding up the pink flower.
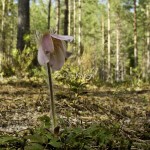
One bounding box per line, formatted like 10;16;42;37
47;62;56;131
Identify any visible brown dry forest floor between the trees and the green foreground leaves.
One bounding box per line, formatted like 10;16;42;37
0;78;150;147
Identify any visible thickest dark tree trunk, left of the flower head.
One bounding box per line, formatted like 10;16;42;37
17;0;30;51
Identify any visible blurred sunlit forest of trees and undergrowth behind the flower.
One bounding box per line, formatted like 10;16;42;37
0;0;150;83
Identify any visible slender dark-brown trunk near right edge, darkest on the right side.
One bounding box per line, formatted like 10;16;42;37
134;0;138;68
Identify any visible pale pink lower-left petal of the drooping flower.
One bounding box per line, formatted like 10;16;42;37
38;47;49;65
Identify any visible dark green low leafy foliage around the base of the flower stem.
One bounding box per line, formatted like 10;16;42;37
0;116;131;150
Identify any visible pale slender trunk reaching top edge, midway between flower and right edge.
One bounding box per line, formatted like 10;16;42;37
107;0;111;81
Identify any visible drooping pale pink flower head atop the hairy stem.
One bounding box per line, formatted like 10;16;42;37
38;33;73;70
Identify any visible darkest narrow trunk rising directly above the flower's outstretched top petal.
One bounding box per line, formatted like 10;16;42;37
64;0;69;35
